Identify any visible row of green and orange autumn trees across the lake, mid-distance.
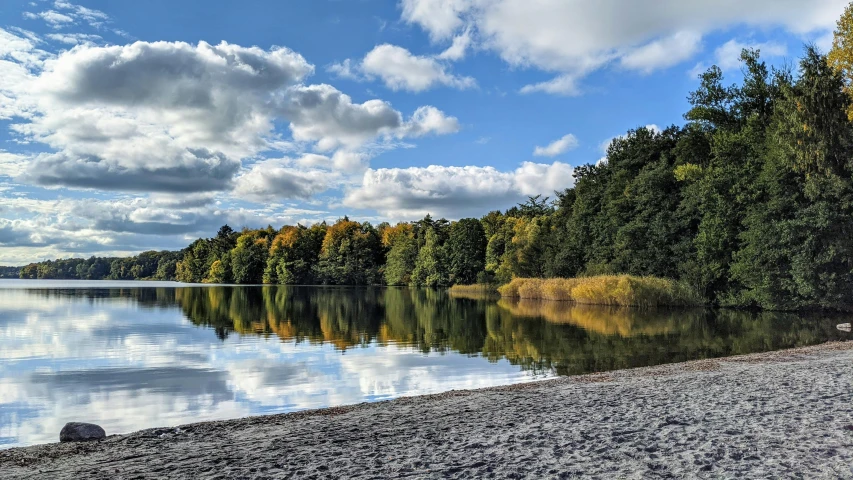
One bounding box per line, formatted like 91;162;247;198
176;215;487;287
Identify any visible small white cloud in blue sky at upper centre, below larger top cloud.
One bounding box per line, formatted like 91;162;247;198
329;44;476;92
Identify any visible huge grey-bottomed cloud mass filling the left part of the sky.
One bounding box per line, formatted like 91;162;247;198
0;29;458;197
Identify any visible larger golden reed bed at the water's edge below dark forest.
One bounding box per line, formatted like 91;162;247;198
498;275;703;307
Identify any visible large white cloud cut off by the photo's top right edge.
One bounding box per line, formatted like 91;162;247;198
401;0;847;94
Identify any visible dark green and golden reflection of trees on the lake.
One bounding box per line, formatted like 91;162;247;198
21;286;849;375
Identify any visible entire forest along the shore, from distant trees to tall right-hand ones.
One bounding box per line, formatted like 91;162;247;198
11;11;853;309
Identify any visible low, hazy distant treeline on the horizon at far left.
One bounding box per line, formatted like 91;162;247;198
16;250;183;280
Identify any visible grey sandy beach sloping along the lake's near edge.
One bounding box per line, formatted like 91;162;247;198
0;342;853;480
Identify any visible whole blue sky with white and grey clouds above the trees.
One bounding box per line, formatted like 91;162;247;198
0;0;847;265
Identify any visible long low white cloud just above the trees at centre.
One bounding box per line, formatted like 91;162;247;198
343;162;574;220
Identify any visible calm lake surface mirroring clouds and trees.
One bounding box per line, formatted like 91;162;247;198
0;280;850;448
